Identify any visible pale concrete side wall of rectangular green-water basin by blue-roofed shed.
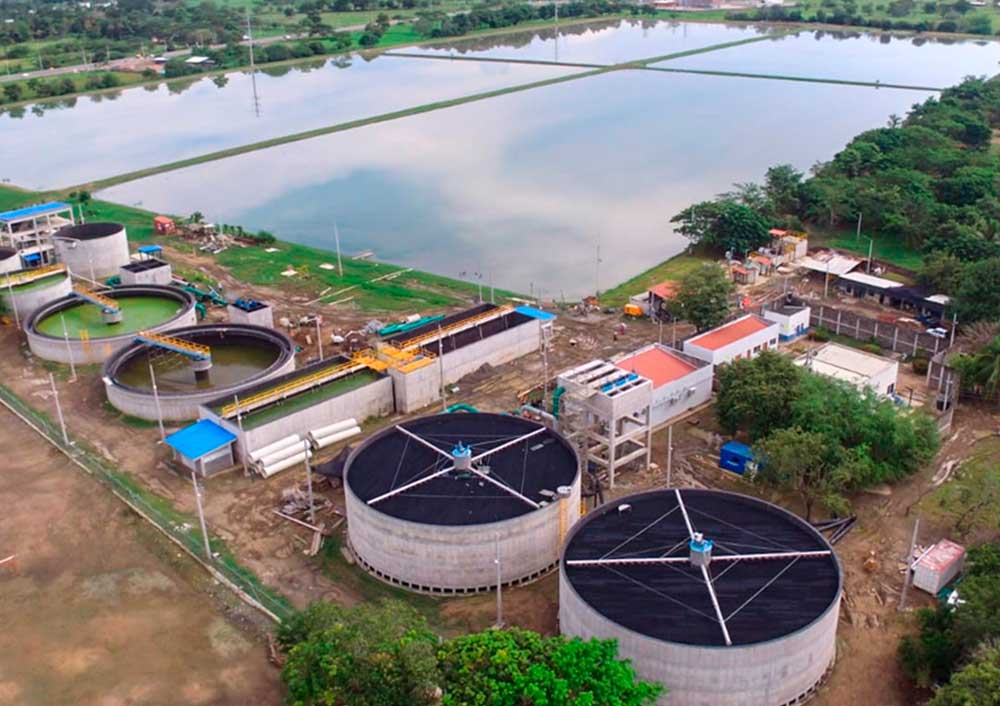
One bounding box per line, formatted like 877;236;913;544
197;377;393;461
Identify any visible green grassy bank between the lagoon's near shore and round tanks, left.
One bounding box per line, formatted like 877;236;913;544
0;186;515;312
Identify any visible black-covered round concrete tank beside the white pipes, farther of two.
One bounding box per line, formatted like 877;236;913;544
344;413;580;593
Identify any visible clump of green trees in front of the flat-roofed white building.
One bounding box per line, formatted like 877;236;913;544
715;351;939;518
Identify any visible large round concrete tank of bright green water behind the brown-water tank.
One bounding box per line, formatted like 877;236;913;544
24;285;197;365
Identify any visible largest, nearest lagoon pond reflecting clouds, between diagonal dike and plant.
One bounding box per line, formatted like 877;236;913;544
102;71;928;297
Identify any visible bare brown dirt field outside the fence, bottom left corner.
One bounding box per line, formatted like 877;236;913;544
0;409;281;706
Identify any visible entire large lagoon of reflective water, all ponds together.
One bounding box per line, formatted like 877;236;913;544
0;22;1000;297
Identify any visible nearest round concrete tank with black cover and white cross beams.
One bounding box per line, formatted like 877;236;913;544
559;489;842;706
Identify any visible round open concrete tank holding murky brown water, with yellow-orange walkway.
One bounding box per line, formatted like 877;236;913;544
103;324;295;421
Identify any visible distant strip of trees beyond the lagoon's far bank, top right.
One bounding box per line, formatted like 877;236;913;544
726;0;993;35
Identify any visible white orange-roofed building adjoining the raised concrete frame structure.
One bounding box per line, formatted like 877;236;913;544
613;343;712;427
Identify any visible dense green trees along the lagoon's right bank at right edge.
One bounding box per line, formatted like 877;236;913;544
673;78;1000;321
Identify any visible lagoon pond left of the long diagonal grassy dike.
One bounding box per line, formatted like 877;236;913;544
0;57;572;189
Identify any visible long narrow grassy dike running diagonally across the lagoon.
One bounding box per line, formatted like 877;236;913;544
78;30;791;191
